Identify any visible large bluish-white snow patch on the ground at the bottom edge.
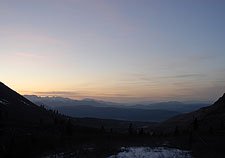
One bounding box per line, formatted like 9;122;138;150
108;147;192;158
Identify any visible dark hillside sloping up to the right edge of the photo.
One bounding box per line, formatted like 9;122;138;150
159;94;225;131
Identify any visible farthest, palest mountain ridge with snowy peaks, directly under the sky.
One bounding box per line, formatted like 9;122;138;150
24;95;210;113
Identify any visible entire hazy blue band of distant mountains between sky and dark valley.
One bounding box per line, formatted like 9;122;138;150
25;95;207;122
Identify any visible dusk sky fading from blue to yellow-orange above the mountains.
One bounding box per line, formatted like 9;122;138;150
0;0;225;102
